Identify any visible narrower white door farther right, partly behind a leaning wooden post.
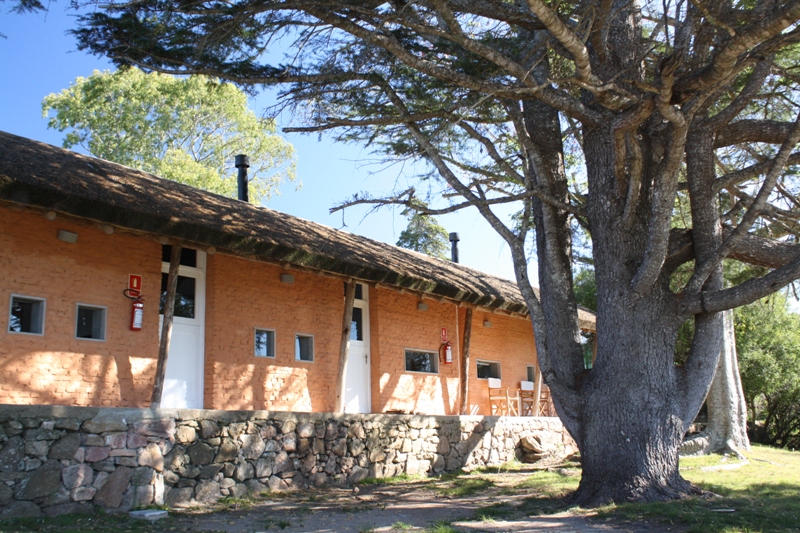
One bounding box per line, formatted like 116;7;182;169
344;283;372;413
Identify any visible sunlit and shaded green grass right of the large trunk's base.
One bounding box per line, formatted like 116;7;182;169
600;446;800;533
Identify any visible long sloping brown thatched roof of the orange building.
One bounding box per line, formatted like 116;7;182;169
0;132;589;319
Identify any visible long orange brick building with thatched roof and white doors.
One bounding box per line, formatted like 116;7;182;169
0;132;593;414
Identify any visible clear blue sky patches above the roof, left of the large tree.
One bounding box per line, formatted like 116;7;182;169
0;6;524;279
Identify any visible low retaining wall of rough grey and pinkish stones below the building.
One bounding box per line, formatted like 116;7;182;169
0;405;574;518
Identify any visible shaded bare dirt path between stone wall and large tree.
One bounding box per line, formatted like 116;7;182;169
170;472;682;533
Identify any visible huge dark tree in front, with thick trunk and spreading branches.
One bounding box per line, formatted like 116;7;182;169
70;0;800;504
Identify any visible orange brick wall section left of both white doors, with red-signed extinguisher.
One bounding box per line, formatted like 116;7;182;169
0;206;161;406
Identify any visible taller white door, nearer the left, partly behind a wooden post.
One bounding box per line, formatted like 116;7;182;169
159;250;206;409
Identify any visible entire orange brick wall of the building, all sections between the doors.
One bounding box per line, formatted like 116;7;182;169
0;202;536;414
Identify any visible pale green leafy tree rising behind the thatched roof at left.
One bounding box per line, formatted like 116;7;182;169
42;68;295;203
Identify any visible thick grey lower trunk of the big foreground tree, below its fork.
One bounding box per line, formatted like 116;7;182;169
575;282;691;505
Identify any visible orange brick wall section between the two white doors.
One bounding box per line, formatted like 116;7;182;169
205;254;344;412
